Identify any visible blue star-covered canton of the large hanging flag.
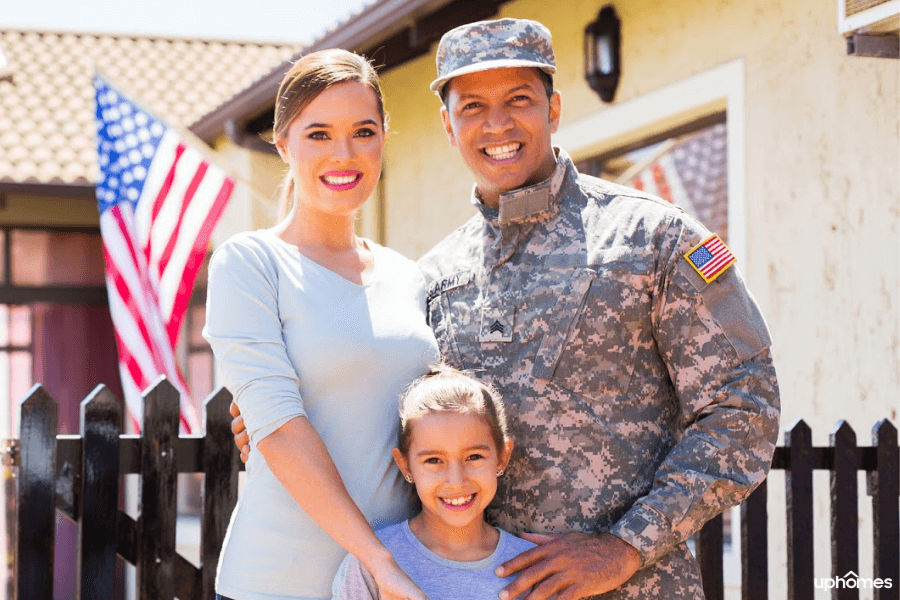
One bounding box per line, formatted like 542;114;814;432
94;75;166;213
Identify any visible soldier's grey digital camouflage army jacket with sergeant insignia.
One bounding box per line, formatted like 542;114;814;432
419;150;779;598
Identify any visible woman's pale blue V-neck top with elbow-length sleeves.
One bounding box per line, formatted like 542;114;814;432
204;231;439;600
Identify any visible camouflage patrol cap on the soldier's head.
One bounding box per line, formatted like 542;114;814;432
430;19;556;96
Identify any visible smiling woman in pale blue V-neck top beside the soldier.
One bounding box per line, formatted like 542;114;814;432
204;50;439;600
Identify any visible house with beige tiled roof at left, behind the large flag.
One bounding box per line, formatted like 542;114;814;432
0;30;296;598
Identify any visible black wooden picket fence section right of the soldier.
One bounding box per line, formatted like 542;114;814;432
697;420;900;600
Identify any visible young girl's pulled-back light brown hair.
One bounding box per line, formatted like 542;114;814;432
397;364;509;456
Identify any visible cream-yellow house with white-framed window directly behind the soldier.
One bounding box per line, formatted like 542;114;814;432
191;0;900;597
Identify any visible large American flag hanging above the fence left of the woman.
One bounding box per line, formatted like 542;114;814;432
94;75;234;432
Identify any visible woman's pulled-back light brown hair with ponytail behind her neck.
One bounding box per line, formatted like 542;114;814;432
273;48;387;217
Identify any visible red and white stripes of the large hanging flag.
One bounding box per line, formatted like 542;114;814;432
100;131;234;432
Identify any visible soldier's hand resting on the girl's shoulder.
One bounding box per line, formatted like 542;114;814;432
497;533;641;600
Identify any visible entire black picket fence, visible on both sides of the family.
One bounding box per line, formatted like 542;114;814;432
7;380;900;600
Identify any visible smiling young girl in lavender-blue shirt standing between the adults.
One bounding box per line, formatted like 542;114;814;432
332;366;534;600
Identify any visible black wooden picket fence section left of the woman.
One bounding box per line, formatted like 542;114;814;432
15;380;241;600
